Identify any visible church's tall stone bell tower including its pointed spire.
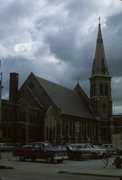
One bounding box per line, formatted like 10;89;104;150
89;22;112;144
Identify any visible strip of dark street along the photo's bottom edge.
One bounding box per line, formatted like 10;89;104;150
0;170;118;180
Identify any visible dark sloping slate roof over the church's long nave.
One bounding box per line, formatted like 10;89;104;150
36;76;95;119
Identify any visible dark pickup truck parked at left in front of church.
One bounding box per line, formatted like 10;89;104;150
12;142;68;163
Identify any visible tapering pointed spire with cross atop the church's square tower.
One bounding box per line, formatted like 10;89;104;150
92;17;110;76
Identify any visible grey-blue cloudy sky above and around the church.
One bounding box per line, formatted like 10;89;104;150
0;0;122;113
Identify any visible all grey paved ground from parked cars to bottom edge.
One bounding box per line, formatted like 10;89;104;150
0;152;122;180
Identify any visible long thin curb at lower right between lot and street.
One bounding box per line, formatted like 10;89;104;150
59;171;122;180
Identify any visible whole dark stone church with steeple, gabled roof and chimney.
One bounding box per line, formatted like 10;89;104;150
0;23;114;144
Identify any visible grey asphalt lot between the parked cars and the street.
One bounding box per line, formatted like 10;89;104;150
0;153;122;180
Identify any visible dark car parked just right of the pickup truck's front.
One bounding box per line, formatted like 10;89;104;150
66;144;91;160
